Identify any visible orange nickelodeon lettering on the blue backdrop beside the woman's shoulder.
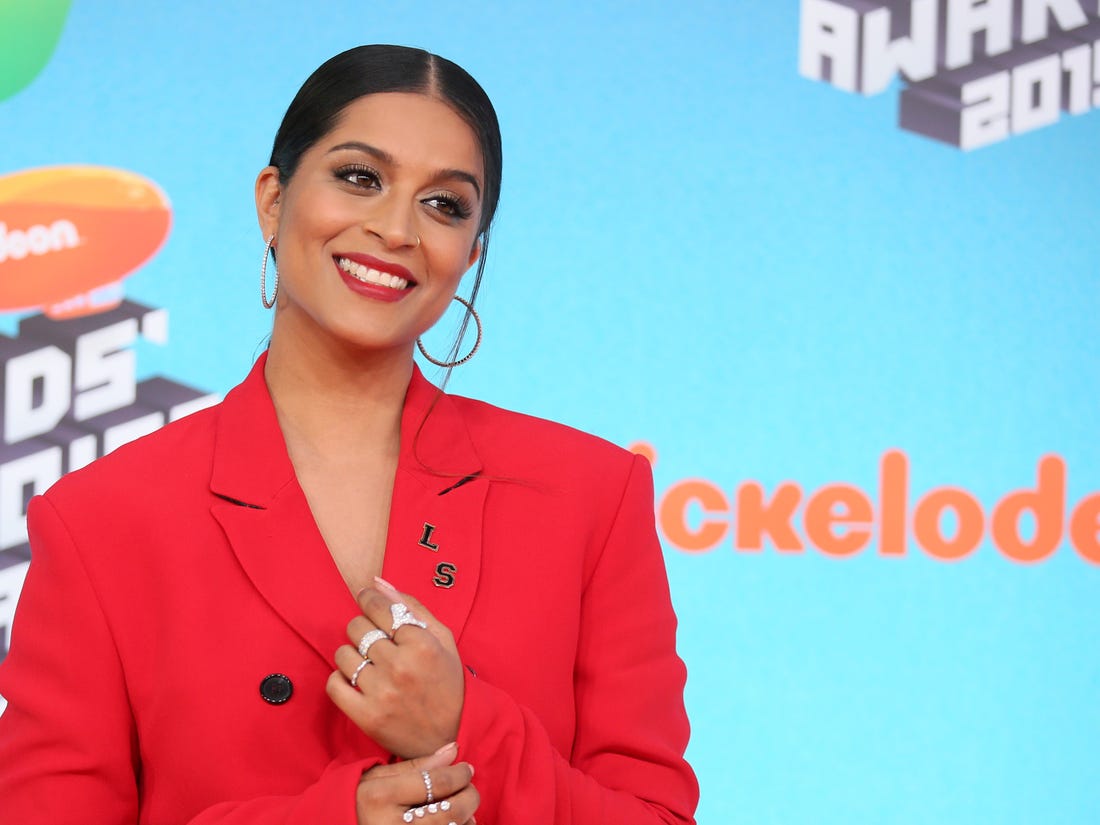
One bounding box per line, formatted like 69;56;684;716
631;444;1100;564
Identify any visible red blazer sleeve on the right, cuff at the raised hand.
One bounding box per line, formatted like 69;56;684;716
459;457;699;825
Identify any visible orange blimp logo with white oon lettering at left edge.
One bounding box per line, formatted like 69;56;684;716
0;166;172;318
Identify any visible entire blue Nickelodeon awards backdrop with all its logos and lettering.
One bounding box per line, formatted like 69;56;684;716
0;0;1100;825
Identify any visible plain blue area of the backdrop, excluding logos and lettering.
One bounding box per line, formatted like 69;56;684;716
0;0;1100;825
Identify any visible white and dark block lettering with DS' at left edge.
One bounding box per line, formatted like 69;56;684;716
0;301;219;659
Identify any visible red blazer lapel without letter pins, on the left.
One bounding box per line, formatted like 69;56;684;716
210;355;359;666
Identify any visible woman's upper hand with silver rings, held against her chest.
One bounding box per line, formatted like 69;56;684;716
327;581;464;759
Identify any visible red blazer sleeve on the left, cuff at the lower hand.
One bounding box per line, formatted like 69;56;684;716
0;497;376;825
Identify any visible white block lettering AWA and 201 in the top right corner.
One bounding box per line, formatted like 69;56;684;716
799;0;1100;150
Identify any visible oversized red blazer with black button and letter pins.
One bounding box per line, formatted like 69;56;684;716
0;359;699;825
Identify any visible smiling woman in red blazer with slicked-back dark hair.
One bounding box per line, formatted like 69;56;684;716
0;46;697;825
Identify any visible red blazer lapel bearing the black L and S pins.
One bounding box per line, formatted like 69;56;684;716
382;370;488;639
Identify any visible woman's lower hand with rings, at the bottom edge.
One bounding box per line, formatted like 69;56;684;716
355;743;481;825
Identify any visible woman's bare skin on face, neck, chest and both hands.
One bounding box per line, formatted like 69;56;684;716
256;94;484;825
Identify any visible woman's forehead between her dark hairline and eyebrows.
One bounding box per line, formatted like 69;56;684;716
317;92;484;180
